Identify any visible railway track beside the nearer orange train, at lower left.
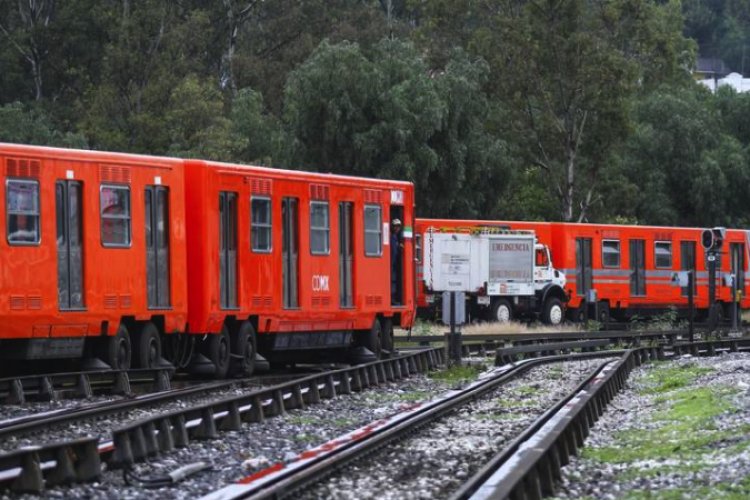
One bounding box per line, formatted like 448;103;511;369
0;349;442;492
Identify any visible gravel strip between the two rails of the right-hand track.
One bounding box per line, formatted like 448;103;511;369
302;359;605;499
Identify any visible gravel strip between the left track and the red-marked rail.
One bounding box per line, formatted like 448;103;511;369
41;368;470;499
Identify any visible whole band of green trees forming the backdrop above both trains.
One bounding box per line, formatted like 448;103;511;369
0;0;750;227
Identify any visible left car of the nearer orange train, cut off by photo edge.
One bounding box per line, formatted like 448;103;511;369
0;144;188;368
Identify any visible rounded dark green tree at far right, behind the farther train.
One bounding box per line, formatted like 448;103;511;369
624;85;750;226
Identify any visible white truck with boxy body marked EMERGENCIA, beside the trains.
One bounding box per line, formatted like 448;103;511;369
423;230;567;325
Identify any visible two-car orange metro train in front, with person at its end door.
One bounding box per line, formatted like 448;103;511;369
0;144;415;378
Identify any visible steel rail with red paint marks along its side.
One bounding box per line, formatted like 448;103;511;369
204;350;623;500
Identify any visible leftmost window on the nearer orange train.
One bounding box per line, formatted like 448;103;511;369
5;179;40;245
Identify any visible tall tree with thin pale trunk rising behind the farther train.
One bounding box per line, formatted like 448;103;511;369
421;0;690;221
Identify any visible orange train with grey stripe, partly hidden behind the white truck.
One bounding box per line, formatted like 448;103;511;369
415;219;750;322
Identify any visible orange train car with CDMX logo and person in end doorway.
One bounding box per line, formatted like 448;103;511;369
185;161;414;375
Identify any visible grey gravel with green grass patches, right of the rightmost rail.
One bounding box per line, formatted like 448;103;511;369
557;353;750;499
